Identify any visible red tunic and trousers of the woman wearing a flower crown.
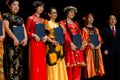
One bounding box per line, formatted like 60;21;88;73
60;20;84;80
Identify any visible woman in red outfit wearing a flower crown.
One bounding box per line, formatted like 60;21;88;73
60;6;86;80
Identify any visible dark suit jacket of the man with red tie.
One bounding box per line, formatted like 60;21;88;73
103;26;120;55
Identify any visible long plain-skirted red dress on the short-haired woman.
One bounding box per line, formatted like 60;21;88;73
26;14;47;80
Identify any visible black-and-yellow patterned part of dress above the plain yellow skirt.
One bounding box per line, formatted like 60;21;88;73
46;21;64;66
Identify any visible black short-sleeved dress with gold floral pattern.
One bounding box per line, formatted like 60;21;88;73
3;13;24;80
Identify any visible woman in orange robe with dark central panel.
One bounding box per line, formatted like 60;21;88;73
82;13;105;78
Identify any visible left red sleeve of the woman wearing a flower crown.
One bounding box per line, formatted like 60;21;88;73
60;21;72;44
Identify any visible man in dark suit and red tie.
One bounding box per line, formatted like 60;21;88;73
103;15;120;80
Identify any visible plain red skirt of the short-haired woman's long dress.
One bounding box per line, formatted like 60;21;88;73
29;40;47;80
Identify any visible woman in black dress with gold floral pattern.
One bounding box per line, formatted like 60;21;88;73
3;0;27;80
